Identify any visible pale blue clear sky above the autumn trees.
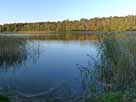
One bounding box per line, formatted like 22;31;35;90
0;0;136;24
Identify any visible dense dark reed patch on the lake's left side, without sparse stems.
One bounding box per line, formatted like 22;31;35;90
0;37;27;68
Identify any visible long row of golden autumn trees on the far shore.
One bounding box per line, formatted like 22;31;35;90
0;15;136;32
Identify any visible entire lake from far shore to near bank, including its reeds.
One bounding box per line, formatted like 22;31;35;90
0;33;136;100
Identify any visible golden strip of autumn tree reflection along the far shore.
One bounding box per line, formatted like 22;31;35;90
3;34;99;41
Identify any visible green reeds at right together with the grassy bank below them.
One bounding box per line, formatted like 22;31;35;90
78;34;136;102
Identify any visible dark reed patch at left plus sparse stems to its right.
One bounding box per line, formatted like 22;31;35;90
0;36;39;70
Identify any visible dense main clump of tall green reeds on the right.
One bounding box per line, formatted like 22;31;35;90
99;35;136;90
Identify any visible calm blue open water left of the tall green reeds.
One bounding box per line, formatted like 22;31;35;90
0;34;99;96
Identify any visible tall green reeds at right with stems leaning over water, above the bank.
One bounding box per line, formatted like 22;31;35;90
80;34;136;102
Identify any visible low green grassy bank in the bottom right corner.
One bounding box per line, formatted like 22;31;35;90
86;88;136;102
